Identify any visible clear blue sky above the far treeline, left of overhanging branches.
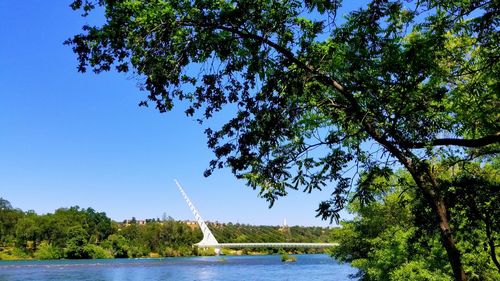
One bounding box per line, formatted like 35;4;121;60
0;0;364;226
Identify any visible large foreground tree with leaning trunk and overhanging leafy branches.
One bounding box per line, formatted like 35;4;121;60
66;0;500;280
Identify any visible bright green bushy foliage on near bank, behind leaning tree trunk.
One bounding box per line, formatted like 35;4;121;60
333;163;500;281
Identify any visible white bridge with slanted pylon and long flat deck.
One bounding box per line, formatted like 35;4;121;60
174;180;338;254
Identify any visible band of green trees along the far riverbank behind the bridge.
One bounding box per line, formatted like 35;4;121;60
0;198;338;260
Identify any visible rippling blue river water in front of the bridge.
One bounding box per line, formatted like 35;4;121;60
0;255;356;281
